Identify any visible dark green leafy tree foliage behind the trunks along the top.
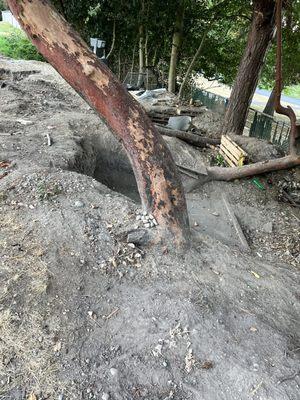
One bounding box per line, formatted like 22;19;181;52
45;0;300;87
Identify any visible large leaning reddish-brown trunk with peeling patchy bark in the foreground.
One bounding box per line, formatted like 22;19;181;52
8;0;189;242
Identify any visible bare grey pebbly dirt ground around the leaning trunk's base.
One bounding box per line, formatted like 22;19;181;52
0;58;300;400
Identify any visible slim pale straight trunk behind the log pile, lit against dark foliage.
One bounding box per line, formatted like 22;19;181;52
168;0;185;93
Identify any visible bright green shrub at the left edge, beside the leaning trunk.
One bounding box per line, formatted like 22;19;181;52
0;29;43;61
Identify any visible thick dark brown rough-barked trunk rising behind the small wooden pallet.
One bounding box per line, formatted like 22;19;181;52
223;0;275;135
